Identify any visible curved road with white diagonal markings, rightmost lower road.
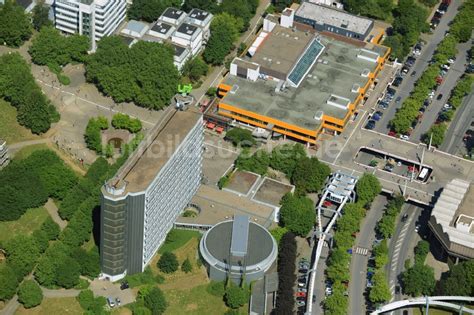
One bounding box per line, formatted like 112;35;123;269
386;204;423;313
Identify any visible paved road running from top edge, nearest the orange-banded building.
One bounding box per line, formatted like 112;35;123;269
375;1;461;134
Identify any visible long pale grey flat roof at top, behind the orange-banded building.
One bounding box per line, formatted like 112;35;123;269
295;2;373;34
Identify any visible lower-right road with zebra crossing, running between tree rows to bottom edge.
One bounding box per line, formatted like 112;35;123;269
349;195;387;315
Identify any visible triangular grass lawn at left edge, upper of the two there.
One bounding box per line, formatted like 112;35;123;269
0;99;40;144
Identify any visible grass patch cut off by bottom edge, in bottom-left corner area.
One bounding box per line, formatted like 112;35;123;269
15;297;84;315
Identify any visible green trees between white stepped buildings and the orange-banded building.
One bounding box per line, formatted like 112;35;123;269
203;13;244;65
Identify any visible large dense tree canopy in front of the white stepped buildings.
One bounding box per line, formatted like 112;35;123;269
86;36;180;109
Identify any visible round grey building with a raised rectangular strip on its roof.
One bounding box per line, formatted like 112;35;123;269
199;215;278;284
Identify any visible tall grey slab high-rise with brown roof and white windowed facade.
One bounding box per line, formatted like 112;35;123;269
100;108;203;281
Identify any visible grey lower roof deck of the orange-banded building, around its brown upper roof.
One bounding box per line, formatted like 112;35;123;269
221;30;386;130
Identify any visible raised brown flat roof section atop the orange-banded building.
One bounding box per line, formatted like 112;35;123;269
251;25;314;75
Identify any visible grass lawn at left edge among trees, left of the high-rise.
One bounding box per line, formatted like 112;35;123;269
0;207;49;241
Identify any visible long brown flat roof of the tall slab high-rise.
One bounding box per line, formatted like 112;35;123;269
107;108;201;194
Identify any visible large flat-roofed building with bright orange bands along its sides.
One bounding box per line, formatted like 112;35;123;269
218;9;390;145
